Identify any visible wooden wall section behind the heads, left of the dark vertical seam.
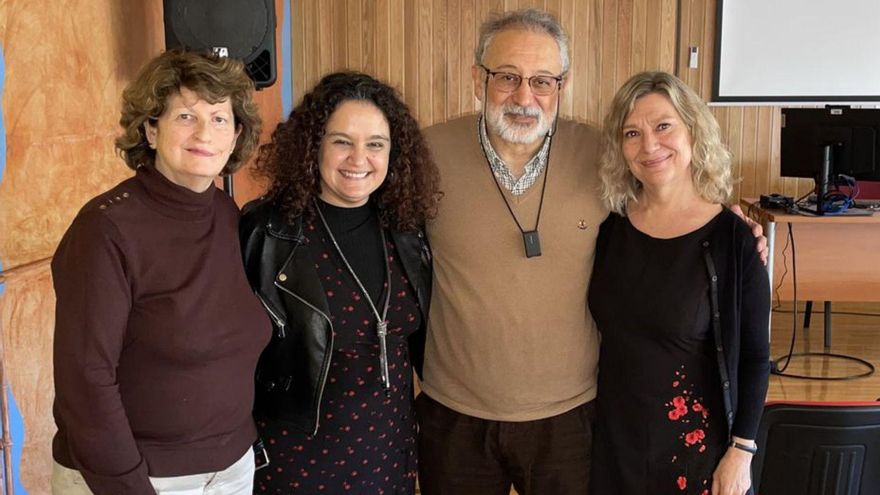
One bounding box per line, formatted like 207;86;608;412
292;0;677;130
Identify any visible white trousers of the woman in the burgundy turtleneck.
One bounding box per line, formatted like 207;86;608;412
52;448;254;495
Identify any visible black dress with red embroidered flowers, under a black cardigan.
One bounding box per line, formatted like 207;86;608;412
589;215;727;495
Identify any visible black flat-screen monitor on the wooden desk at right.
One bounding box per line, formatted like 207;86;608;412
780;107;880;181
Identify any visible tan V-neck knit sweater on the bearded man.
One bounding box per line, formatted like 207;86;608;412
422;116;608;421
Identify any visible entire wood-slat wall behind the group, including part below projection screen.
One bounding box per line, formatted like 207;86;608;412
293;0;812;205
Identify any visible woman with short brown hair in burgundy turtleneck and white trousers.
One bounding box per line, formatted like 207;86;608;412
52;50;270;495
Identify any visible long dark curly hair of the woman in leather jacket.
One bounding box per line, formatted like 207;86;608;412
254;72;440;231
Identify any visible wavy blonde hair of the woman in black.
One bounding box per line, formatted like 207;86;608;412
599;72;733;214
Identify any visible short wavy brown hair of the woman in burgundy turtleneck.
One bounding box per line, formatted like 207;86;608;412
116;48;262;175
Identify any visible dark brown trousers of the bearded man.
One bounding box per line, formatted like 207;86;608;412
416;393;596;495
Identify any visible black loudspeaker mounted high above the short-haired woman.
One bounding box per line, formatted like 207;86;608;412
163;0;276;89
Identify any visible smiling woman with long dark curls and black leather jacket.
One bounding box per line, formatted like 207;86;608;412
240;72;440;494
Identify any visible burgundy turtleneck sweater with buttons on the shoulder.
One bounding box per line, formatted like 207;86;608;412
52;167;271;495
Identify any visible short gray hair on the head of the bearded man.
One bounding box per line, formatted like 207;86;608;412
474;9;571;74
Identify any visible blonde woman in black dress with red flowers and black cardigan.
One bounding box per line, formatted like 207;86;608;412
589;72;770;495
